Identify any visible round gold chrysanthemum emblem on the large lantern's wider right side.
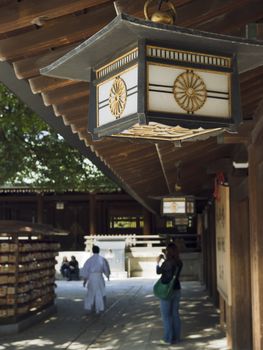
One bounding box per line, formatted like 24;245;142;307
173;71;207;113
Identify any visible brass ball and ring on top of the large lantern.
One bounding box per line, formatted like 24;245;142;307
144;0;176;24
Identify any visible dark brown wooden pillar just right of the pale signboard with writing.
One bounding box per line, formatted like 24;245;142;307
230;174;252;350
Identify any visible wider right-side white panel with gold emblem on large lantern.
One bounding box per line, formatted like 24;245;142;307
148;63;231;118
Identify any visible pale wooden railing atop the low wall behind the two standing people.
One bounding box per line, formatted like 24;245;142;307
85;234;201;252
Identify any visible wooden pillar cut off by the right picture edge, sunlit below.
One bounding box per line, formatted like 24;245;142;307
248;113;263;350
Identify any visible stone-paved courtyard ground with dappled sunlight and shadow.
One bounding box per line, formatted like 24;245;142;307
0;278;227;350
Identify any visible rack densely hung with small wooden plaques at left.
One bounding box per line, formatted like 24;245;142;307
0;222;60;325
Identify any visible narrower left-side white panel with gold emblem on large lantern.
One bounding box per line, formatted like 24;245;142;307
97;65;138;126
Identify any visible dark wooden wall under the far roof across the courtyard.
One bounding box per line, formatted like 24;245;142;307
0;192;201;250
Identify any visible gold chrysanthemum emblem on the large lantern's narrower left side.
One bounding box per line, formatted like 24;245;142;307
109;77;127;119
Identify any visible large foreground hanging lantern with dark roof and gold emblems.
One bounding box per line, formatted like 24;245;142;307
41;14;263;139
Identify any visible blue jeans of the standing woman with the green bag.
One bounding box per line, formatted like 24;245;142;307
160;289;181;344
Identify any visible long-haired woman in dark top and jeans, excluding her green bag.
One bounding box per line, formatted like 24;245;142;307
156;243;183;344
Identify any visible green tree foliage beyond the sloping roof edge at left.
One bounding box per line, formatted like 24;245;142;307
0;85;117;191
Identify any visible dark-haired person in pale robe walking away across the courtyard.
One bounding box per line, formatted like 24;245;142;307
81;245;111;314
